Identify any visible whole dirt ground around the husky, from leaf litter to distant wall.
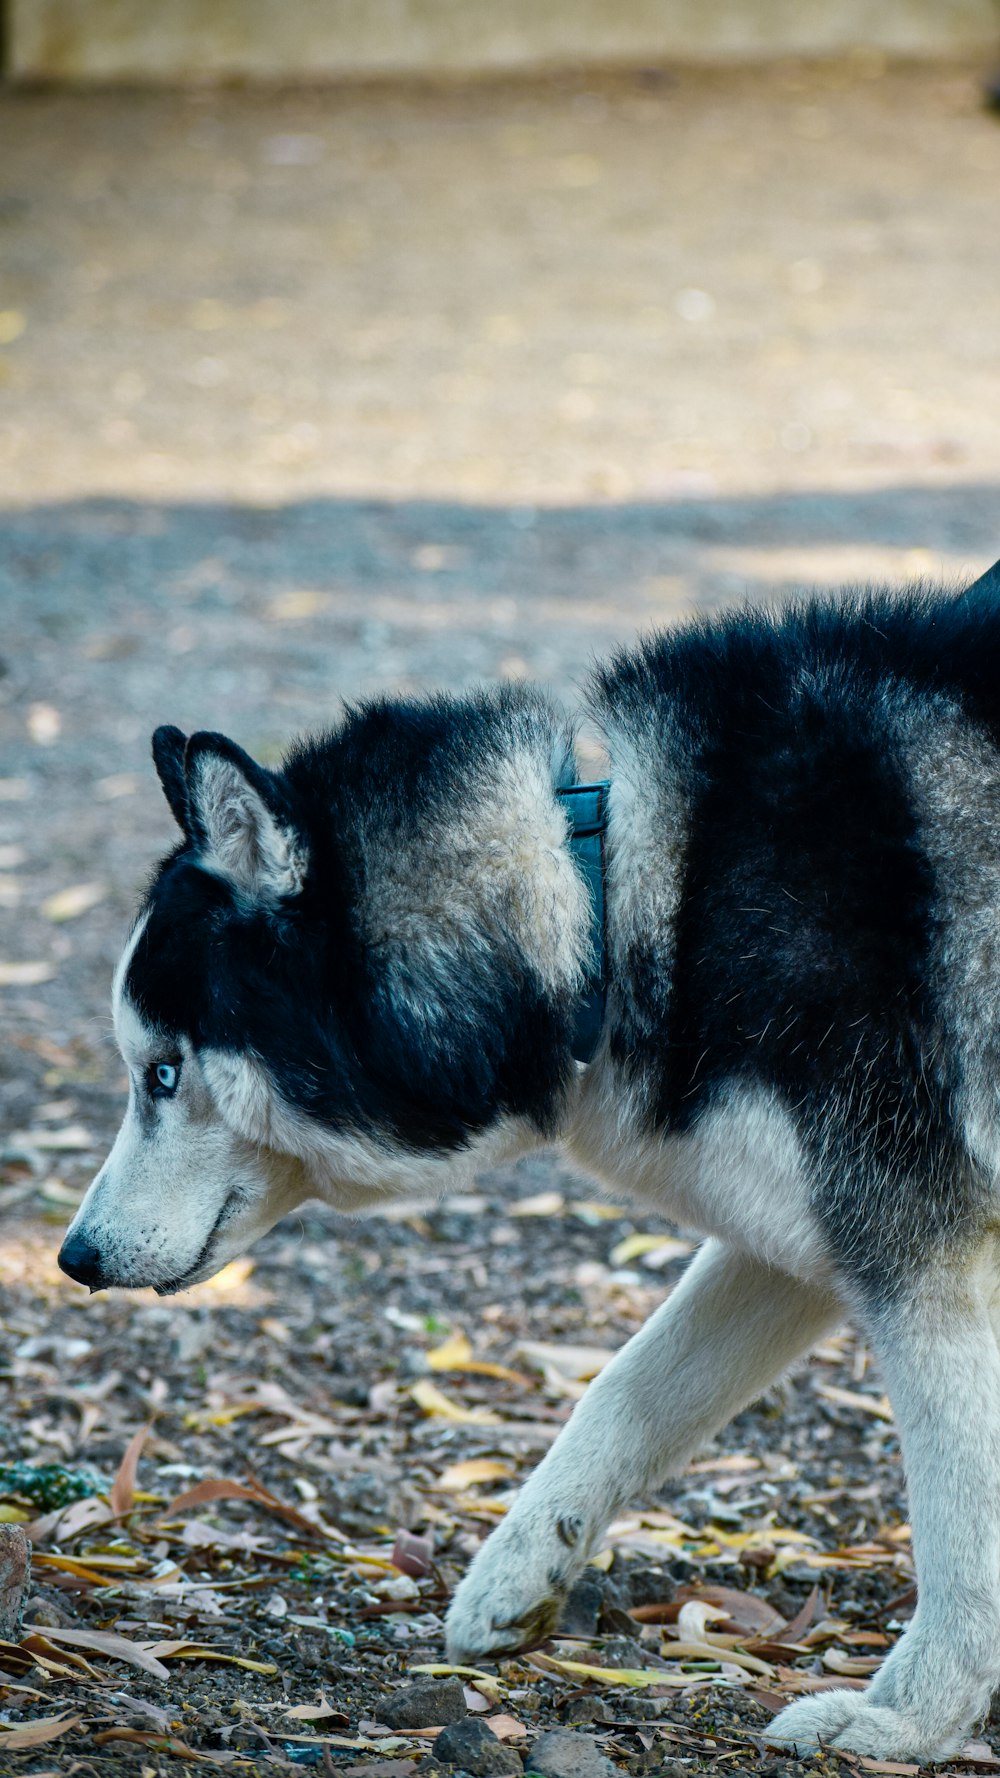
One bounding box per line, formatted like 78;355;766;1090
0;57;1000;1778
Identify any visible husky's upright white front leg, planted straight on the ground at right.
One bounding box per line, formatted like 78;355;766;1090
767;1266;1000;1764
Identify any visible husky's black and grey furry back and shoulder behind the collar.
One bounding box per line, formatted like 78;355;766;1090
580;592;1000;1289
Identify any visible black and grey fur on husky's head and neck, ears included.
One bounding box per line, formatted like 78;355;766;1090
135;688;575;1150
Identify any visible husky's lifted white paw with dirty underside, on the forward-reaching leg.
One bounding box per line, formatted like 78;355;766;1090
445;1527;578;1661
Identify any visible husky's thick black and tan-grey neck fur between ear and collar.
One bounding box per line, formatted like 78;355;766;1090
325;688;603;1143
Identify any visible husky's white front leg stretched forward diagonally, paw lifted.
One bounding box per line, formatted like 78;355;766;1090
448;1241;840;1659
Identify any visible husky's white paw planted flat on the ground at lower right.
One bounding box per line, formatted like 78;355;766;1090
763;1691;963;1766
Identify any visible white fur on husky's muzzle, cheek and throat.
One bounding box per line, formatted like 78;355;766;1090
69;917;537;1291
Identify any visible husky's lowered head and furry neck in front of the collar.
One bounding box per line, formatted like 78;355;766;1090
59;706;580;1293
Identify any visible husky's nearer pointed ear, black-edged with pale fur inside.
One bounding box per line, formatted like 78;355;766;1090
178;733;308;901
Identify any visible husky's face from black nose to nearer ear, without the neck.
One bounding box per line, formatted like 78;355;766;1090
59;729;325;1293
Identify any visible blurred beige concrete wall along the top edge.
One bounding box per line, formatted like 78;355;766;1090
11;0;1000;80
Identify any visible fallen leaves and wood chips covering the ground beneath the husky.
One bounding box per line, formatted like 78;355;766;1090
0;1130;993;1778
